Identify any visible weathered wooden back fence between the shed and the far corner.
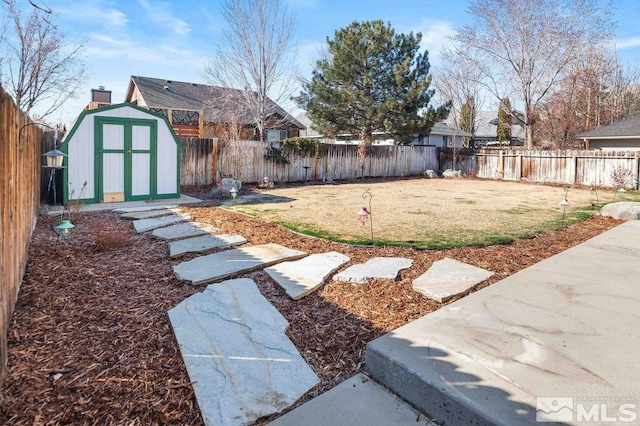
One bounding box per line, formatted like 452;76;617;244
180;139;438;185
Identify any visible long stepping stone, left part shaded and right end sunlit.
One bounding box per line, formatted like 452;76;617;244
173;244;307;284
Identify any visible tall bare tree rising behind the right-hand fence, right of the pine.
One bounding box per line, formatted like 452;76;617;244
454;0;613;149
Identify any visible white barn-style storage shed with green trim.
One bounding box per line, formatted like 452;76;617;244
60;103;182;204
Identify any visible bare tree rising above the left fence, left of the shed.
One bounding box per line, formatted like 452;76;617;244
1;0;86;117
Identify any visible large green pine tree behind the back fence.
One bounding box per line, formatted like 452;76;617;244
296;21;448;155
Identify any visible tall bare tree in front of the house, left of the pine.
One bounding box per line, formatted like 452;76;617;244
203;0;296;140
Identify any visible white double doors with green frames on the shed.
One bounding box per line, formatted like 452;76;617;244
95;117;157;203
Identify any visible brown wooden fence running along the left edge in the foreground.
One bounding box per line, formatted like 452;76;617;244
0;88;42;385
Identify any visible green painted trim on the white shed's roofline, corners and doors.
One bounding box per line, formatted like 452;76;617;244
59;102;184;204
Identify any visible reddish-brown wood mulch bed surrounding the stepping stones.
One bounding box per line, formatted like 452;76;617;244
0;202;621;425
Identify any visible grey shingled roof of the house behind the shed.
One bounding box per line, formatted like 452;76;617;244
126;75;305;129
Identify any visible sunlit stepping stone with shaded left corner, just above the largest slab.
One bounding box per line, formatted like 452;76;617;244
265;251;351;300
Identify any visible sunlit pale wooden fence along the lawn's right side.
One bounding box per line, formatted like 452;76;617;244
476;150;640;189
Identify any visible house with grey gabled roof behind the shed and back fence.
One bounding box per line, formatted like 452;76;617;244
125;76;305;142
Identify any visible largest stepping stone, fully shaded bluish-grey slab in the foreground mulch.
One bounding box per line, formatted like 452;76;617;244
168;278;319;425
